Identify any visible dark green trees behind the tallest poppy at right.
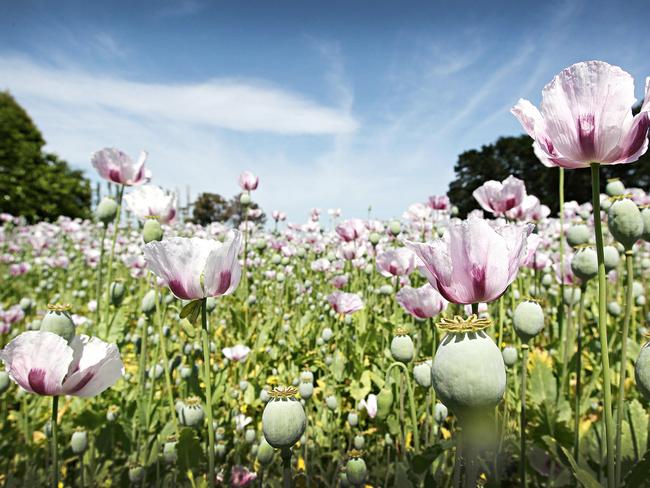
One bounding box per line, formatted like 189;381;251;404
448;135;650;217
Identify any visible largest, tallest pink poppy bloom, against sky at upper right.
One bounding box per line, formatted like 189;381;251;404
511;61;650;169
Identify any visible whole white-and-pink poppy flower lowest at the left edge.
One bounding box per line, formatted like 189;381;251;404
0;331;123;397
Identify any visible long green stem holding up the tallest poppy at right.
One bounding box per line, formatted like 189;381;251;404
591;163;616;488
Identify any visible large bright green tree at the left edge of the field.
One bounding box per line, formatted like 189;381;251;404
0;92;91;222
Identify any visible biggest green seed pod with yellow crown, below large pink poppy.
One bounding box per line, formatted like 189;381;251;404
433;315;506;417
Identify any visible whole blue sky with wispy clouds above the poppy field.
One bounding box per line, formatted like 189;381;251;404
0;0;650;221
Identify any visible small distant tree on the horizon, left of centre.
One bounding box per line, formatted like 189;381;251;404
192;193;266;228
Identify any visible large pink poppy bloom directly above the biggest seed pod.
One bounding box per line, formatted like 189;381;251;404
406;219;534;304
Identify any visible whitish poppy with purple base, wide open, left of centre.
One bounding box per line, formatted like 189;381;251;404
144;231;241;300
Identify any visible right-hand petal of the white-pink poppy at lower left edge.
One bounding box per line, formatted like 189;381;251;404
63;335;124;397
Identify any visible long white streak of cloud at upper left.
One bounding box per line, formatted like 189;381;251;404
0;56;358;134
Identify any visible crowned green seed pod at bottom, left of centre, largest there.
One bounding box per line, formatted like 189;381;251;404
262;387;307;449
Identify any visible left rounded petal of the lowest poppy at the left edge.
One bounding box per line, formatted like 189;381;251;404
0;331;73;395
